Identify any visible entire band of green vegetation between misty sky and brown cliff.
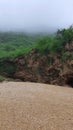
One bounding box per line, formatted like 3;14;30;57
0;26;73;59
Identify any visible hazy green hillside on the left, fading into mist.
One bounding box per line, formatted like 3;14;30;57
0;33;36;58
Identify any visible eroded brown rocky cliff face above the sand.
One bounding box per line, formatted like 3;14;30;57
0;43;73;87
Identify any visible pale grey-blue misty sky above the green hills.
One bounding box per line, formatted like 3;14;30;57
0;0;73;32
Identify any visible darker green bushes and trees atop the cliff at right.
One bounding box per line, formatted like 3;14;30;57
36;26;73;54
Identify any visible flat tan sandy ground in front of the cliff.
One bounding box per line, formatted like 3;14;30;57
0;82;73;130
